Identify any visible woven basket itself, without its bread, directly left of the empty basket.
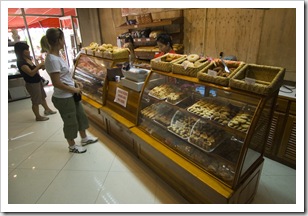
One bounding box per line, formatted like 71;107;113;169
197;59;245;86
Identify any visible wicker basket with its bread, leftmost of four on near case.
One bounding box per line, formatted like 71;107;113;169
150;53;186;73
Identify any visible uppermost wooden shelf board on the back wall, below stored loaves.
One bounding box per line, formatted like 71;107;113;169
117;17;183;30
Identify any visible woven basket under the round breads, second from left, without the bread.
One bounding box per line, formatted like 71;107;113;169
172;58;210;77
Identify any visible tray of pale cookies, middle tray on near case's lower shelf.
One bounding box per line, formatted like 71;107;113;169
167;110;198;140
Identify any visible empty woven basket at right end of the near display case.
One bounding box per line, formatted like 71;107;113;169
229;64;285;95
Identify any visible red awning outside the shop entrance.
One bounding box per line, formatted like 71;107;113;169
8;8;76;29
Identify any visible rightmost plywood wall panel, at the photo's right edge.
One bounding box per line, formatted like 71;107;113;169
258;8;296;81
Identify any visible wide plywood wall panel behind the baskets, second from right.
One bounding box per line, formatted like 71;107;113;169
195;8;263;62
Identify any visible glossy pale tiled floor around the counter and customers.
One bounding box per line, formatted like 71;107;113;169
2;87;296;211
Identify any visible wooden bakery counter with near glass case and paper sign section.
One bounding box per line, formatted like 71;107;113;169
80;52;286;204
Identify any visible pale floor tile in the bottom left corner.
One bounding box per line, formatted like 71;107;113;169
8;169;58;204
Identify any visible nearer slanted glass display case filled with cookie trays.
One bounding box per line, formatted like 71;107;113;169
138;71;278;189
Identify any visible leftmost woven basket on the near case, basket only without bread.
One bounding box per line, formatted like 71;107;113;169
150;53;186;73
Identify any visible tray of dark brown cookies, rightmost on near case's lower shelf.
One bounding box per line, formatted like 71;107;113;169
188;119;225;152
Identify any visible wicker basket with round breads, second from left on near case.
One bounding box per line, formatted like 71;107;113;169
172;54;210;77
